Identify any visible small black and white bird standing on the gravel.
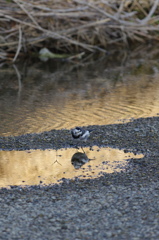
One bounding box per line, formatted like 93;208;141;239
71;127;90;142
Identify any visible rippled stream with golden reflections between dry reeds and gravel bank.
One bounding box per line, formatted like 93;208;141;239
0;49;159;136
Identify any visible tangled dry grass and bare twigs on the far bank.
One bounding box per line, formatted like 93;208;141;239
0;0;159;62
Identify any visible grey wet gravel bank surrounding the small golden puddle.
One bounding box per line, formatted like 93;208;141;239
0;117;159;240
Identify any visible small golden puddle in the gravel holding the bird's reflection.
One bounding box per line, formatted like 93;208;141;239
0;146;143;187
